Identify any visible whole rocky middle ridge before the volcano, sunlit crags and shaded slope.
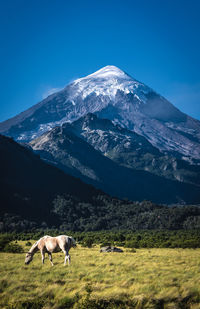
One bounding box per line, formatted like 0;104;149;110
27;114;200;203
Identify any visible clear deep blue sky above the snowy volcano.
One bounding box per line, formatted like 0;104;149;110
0;0;200;121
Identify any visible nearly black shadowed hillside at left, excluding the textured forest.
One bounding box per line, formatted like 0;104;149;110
0;135;106;224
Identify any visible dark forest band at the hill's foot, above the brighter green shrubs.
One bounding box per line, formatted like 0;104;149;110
0;195;200;232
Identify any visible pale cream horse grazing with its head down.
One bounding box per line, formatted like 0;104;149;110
25;235;76;266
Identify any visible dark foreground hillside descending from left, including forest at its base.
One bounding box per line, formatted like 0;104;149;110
0;132;199;232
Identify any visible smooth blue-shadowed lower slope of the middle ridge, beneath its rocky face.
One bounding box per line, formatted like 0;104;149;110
30;122;200;204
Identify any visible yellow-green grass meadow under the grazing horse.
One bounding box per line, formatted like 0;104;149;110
0;241;200;309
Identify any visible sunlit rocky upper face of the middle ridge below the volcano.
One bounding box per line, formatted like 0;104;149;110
64;114;200;185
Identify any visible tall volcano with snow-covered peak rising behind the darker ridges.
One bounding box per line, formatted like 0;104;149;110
0;66;200;160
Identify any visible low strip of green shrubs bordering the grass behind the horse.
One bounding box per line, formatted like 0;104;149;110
0;229;200;253
